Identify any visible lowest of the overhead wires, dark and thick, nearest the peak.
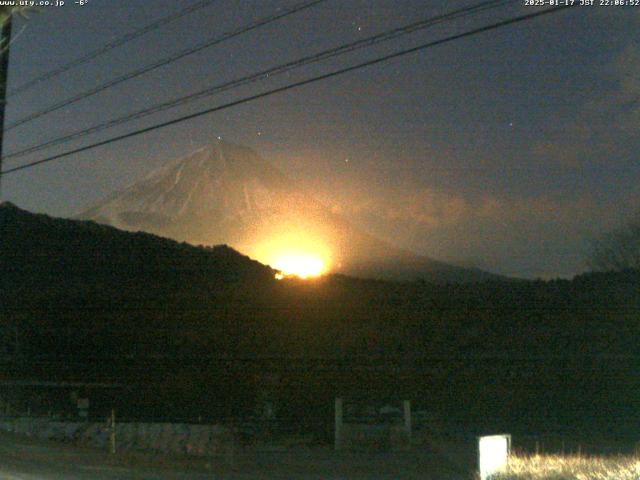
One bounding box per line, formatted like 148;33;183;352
0;5;573;175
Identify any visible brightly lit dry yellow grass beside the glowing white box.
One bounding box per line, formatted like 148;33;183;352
491;455;640;480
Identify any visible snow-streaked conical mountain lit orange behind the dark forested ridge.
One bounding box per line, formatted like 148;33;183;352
75;141;499;282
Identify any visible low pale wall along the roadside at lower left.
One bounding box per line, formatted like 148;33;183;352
0;417;235;455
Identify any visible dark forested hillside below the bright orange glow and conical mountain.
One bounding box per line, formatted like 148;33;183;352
0;204;640;436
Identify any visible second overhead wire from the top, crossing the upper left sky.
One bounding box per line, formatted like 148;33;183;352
5;0;326;131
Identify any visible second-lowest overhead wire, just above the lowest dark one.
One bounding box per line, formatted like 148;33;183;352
4;0;515;159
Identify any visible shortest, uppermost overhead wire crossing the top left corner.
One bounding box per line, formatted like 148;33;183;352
8;0;217;97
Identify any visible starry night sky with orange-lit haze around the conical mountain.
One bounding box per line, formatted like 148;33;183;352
2;0;640;278
